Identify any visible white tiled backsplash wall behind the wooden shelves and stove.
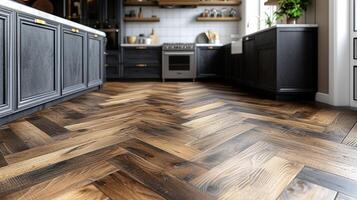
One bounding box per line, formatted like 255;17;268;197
125;6;241;43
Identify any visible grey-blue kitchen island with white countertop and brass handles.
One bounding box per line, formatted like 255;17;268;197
0;0;105;124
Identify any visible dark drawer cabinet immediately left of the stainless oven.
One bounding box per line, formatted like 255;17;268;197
123;47;162;79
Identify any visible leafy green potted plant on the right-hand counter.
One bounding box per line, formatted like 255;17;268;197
275;0;311;24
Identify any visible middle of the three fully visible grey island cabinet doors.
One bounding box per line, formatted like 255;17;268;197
62;27;87;94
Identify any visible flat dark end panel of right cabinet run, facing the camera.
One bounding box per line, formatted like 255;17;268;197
277;29;317;91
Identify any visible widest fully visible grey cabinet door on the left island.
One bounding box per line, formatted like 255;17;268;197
17;14;60;109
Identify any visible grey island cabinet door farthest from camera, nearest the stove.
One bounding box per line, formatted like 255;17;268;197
88;34;104;87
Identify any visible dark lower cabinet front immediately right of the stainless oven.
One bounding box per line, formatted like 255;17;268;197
197;47;224;78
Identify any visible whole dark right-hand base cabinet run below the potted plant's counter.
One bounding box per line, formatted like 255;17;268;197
241;27;317;99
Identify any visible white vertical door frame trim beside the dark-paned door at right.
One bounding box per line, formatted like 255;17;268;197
325;0;352;106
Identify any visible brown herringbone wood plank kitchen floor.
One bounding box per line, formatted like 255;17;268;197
0;82;357;200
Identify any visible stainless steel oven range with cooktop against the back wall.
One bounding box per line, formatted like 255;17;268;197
162;44;196;81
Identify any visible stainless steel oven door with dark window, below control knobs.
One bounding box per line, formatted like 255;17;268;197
163;52;196;79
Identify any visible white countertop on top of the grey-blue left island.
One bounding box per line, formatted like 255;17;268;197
0;0;106;36
